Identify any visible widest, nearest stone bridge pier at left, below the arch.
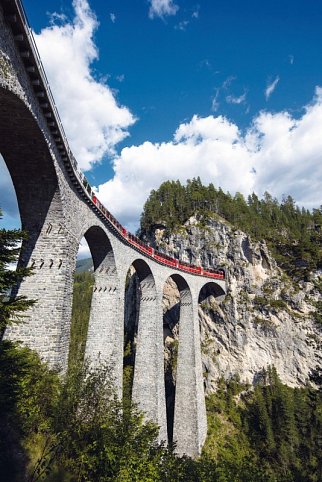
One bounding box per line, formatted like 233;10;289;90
4;191;78;372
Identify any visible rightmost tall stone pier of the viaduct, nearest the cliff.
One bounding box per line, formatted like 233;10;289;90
167;274;207;457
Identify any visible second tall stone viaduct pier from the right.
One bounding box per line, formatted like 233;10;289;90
132;258;167;440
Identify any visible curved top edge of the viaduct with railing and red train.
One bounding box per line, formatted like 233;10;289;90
2;0;225;280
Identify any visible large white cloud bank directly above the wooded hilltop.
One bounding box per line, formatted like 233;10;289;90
98;87;322;230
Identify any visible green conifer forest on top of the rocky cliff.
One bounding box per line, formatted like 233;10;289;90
141;181;322;279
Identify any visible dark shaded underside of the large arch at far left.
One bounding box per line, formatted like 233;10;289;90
0;87;62;264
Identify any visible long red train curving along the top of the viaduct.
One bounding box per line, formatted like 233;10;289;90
87;188;225;280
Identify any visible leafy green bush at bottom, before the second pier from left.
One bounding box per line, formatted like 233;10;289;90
49;363;171;482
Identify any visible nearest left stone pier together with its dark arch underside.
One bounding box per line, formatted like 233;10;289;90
0;87;76;370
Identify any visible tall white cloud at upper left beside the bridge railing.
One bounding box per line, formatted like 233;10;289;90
35;0;135;170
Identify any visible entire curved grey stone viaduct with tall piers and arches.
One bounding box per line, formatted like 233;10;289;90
0;0;225;456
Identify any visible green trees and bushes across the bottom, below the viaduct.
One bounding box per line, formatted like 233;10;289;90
0;213;322;482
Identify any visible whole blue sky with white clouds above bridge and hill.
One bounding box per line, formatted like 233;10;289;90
0;0;322;229
